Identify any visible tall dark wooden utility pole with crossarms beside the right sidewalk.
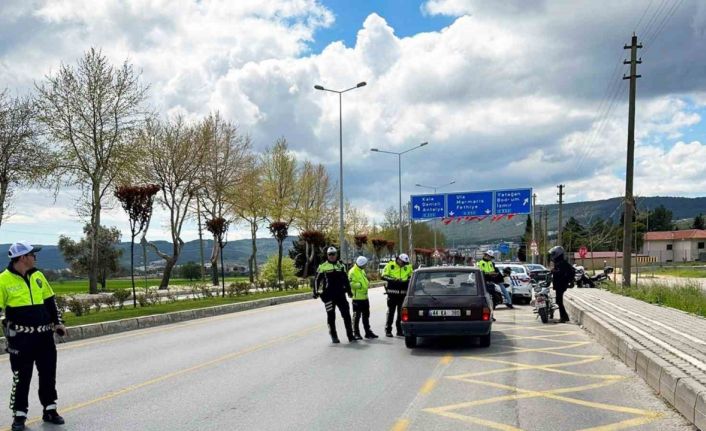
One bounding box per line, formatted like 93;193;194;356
623;33;642;287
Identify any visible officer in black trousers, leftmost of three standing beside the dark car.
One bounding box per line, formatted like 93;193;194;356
314;247;356;344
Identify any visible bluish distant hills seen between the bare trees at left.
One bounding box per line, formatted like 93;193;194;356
0;237;294;269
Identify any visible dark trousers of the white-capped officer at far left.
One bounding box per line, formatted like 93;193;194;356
7;331;58;413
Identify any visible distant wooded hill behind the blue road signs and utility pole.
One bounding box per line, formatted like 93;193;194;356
439;196;706;246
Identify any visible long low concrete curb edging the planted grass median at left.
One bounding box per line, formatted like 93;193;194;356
0;282;383;355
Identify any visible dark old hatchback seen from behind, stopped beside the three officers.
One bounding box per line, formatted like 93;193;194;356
402;266;493;349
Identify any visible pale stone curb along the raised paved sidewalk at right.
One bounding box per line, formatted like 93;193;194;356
564;296;706;430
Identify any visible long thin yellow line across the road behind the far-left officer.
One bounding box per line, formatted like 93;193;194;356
2;325;324;431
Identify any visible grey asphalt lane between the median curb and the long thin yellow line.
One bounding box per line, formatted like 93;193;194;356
0;294;336;428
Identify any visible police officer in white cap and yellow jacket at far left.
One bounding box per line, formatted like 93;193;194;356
0;242;66;431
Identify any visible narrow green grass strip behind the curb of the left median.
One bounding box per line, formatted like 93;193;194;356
64;288;311;326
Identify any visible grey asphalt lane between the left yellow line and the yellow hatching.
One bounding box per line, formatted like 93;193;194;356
2;294;446;430
